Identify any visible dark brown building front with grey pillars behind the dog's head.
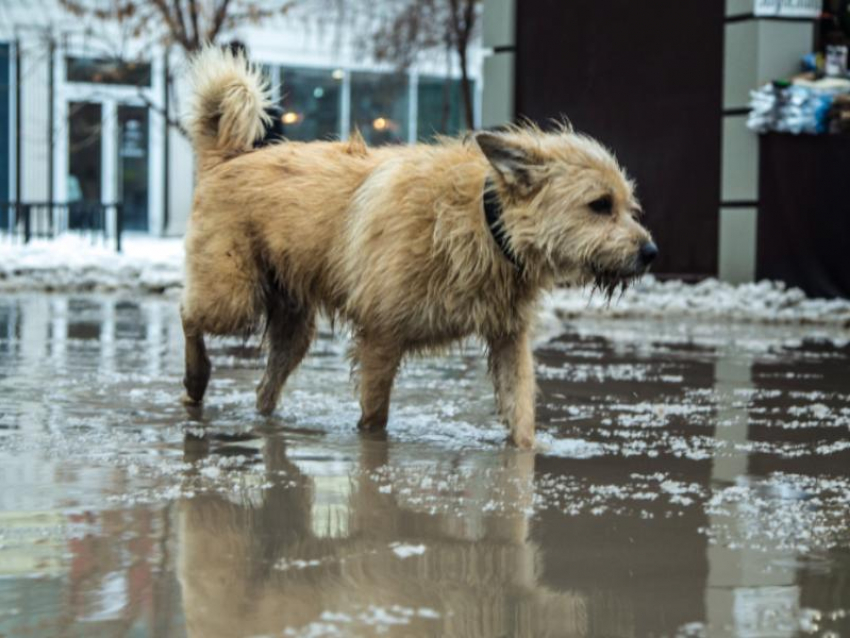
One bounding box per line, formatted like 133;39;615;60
482;0;820;286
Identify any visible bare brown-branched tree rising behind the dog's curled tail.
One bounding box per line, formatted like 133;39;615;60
59;0;295;135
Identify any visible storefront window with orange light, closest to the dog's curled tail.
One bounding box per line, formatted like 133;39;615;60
279;67;342;141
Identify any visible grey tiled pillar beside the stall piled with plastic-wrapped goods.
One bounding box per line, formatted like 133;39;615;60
718;0;814;283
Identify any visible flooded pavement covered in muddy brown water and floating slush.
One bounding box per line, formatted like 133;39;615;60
0;295;850;638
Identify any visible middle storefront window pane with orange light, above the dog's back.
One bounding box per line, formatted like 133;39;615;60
351;73;408;146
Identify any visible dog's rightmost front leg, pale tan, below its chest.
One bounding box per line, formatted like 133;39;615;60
489;331;537;449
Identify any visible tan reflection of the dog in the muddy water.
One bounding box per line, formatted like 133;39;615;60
179;438;587;638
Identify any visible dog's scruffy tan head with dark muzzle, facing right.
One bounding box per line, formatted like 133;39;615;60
475;127;658;295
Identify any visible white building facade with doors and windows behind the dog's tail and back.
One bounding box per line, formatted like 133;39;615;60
0;0;480;235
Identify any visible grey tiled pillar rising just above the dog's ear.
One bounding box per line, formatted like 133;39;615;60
481;0;516;128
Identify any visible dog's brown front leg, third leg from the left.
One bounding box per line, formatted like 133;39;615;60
355;337;403;430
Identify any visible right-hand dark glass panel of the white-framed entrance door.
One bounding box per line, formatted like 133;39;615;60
116;104;149;231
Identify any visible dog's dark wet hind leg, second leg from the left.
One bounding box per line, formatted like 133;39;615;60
257;292;316;415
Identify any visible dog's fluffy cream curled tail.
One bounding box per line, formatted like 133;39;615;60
186;46;271;160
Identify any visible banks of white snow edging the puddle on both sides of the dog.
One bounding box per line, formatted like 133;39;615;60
0;235;850;332
